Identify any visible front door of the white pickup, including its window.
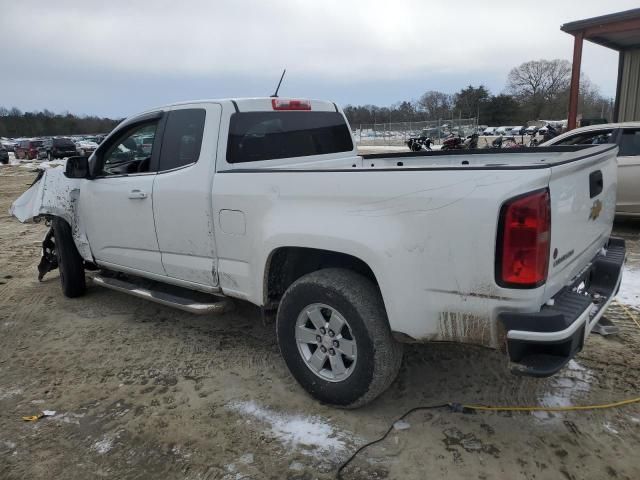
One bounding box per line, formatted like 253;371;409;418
79;114;166;275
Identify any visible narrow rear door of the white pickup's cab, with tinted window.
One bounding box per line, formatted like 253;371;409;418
153;104;222;286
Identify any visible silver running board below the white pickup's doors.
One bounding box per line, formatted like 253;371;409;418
87;273;232;315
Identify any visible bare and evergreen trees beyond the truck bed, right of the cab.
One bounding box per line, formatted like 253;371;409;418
344;59;613;128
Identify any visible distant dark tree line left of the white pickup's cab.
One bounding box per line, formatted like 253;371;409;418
0;106;121;138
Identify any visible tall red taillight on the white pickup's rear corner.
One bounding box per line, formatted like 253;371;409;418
496;189;551;288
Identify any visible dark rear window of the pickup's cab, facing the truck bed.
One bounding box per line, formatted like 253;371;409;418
227;111;353;163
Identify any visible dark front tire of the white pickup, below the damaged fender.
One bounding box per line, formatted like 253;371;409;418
52;217;87;298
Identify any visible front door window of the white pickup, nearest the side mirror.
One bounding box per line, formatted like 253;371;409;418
98;121;158;176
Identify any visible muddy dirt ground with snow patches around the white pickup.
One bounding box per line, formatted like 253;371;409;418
0;166;640;480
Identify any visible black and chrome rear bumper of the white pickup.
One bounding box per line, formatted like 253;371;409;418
498;237;626;377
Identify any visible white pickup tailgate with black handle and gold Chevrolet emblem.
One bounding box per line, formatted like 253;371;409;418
545;145;618;300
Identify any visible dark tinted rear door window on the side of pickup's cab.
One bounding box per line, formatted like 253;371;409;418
159;108;206;171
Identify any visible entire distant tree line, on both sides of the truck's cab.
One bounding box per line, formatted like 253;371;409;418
0;59;613;137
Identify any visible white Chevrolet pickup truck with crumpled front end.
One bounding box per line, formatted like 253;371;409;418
11;98;625;407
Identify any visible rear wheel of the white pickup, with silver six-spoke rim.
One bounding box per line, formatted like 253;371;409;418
276;268;403;408
